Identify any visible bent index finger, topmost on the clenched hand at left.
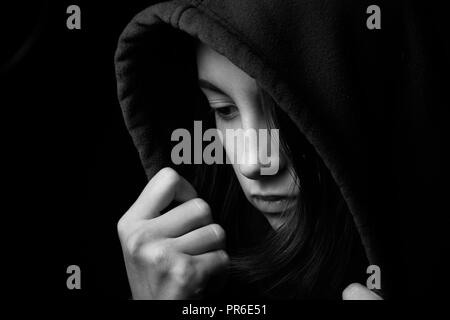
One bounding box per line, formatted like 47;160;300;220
126;168;197;220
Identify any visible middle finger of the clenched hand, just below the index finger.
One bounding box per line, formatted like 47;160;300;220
152;198;212;238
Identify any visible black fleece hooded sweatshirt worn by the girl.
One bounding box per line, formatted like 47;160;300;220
115;0;449;298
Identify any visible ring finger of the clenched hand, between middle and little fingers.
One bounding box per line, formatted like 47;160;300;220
174;224;225;255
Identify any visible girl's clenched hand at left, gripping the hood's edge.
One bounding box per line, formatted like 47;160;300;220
117;168;229;299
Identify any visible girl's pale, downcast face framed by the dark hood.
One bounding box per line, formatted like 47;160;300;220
197;44;299;229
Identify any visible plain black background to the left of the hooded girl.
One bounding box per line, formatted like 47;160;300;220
1;1;156;299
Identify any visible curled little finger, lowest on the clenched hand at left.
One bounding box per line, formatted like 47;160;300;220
193;250;230;283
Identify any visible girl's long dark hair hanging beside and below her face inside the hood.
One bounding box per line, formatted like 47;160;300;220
190;80;363;299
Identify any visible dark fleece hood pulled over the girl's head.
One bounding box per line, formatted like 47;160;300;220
115;0;450;295
